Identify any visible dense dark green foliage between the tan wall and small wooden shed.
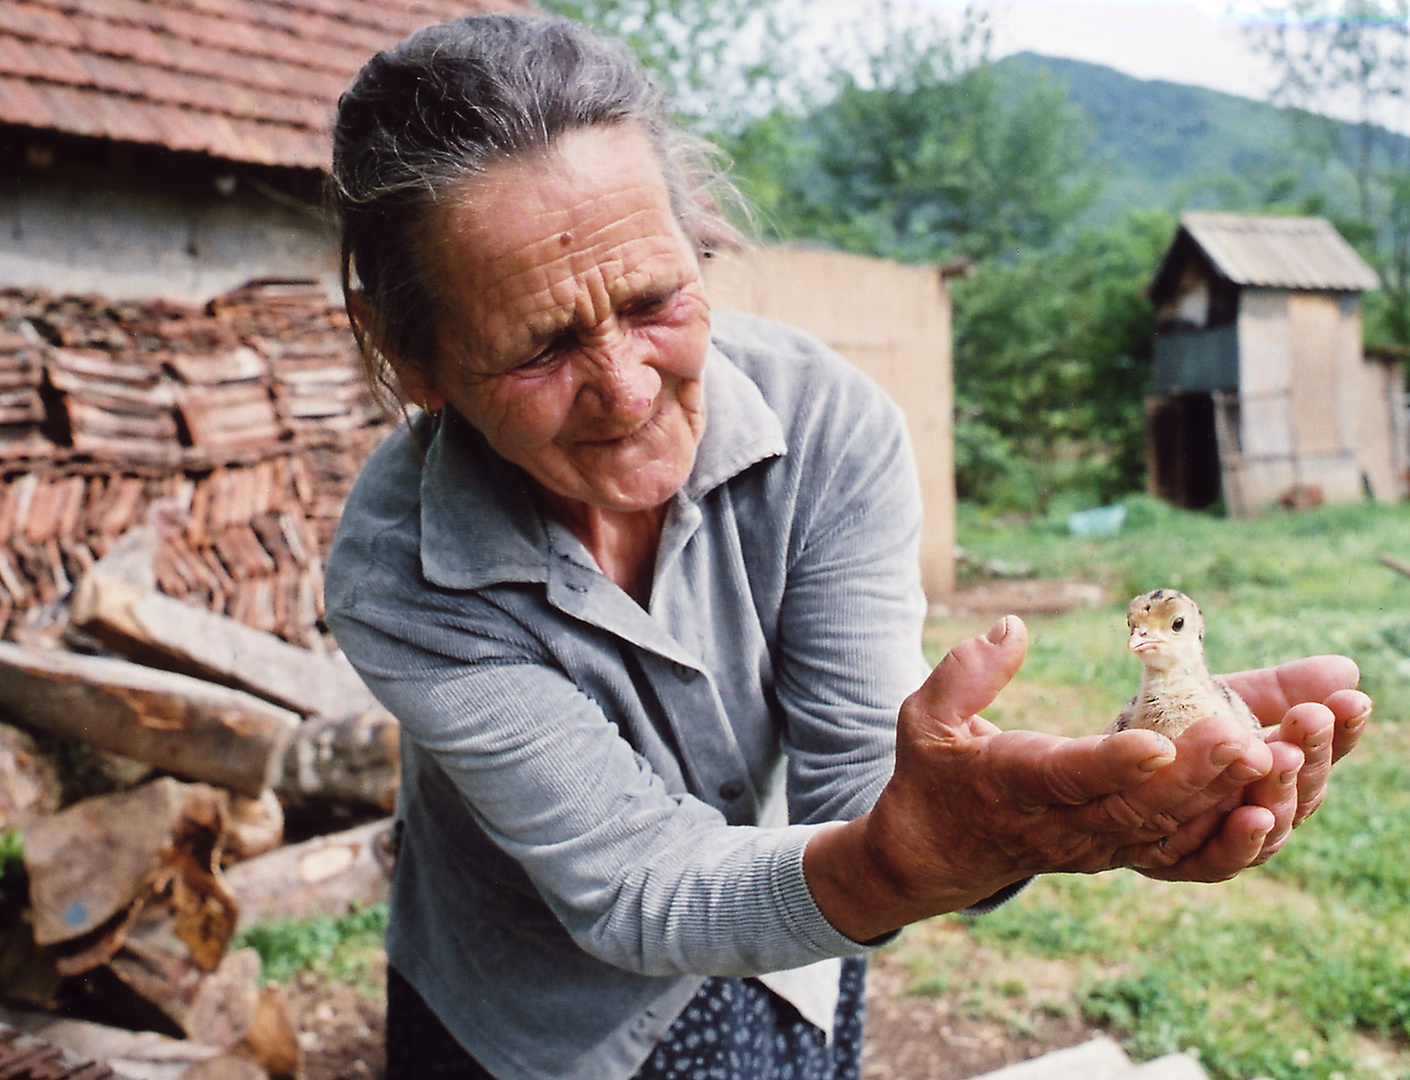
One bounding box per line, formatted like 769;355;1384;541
955;211;1175;513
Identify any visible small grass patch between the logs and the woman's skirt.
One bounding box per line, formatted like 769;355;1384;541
235;904;386;991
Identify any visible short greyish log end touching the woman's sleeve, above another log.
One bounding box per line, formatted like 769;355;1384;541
278;708;400;814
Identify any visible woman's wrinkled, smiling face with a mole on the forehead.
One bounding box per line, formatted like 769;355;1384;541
400;127;709;510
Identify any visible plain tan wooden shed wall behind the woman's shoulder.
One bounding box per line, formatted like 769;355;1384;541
705;247;955;601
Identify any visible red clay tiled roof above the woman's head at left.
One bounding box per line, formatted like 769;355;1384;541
0;0;530;169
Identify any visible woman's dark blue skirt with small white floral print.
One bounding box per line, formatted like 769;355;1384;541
386;957;867;1080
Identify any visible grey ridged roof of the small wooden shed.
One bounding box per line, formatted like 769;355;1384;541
1180;213;1380;292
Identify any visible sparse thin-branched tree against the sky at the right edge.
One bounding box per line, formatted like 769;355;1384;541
1252;0;1410;344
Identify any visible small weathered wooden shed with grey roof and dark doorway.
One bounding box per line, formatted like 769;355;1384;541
1146;213;1410;517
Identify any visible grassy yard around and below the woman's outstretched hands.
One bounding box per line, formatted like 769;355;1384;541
894;499;1410;1080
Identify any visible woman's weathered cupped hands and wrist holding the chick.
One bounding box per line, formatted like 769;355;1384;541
804;616;1371;940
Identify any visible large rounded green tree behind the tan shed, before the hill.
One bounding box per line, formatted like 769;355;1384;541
728;7;1096;262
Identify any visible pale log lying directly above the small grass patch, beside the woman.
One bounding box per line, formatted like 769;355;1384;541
226;818;393;929
